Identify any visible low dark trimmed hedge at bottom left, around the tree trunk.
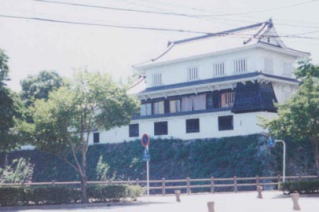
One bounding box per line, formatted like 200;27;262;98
0;185;143;206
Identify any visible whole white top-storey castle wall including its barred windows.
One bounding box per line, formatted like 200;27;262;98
145;48;295;88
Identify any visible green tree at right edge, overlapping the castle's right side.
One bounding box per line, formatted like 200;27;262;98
265;61;319;175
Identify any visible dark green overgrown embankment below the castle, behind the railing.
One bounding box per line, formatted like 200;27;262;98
0;135;316;182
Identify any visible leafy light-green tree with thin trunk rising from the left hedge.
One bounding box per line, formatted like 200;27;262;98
30;71;137;202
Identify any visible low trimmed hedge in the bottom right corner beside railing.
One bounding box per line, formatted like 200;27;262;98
281;180;319;194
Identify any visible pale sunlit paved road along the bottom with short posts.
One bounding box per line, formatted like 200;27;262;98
0;191;319;212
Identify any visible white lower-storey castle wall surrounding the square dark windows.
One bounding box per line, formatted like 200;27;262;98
90;111;276;144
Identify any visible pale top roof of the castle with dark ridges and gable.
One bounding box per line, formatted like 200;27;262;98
134;20;285;68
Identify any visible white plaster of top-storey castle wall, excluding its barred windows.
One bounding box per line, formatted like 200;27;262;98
145;48;296;87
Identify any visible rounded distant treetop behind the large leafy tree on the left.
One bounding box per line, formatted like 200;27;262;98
20;71;64;106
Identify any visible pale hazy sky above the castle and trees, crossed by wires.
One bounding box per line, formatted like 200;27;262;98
0;0;319;91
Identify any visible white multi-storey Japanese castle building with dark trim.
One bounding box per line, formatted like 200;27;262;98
91;20;309;143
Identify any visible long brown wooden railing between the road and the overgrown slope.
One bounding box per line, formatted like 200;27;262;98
0;176;318;195
